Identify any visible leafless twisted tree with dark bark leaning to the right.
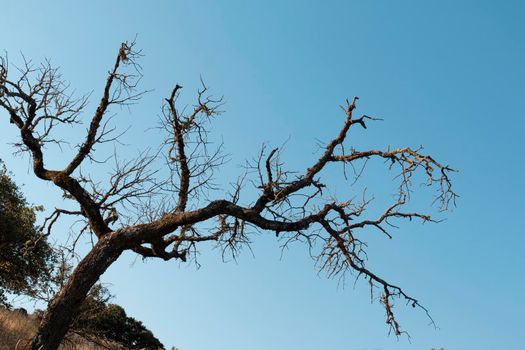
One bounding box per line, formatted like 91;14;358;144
0;42;456;350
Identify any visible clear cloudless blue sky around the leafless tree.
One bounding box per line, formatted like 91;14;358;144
0;0;525;350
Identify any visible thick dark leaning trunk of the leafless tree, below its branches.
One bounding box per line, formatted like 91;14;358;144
29;234;124;350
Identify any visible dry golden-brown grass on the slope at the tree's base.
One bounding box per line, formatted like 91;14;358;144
0;308;127;350
